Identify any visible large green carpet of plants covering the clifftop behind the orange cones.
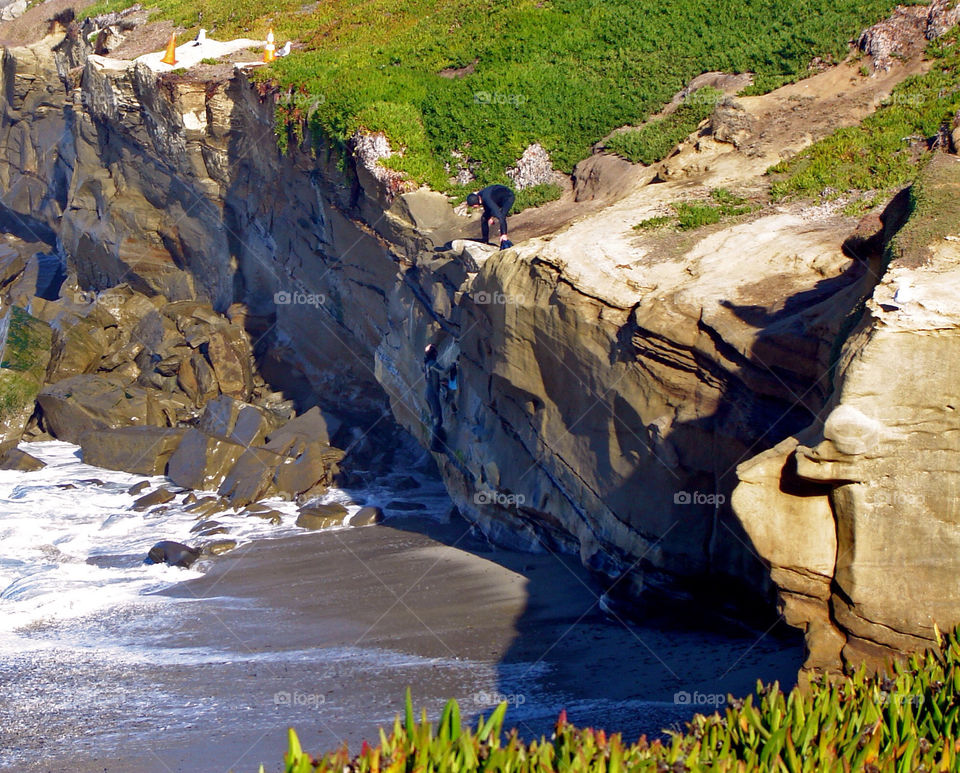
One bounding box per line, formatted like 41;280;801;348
87;0;908;190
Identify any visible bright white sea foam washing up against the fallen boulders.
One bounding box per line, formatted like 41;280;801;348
0;441;449;653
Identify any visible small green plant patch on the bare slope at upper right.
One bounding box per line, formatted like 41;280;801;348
769;31;960;199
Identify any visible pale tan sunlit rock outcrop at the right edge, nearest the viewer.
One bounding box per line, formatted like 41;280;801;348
733;155;960;668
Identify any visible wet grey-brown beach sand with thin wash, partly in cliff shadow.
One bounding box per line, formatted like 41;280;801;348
0;518;802;773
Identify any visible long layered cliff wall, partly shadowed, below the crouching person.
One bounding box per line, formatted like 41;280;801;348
0;27;956;651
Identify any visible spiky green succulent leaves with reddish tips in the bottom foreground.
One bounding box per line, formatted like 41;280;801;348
276;632;960;773
